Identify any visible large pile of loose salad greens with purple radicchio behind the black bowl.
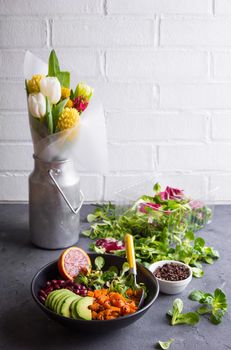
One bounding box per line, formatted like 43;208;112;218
83;184;219;277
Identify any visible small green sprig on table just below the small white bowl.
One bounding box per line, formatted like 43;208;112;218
167;298;200;326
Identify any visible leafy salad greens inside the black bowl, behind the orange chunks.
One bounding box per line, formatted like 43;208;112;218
75;256;145;297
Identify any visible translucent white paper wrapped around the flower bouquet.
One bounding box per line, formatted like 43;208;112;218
24;51;108;173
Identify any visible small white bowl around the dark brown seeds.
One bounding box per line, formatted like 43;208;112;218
149;260;192;294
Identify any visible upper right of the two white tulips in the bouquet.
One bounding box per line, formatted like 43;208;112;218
40;77;61;104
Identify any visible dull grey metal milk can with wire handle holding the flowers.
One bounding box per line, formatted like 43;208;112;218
29;156;83;249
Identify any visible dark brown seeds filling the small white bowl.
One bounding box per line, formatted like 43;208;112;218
154;263;190;281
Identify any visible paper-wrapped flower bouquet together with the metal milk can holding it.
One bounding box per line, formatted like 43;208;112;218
24;50;107;249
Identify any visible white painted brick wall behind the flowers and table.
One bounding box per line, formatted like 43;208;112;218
0;0;231;202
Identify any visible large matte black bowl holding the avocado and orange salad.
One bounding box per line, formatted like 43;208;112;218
31;253;159;332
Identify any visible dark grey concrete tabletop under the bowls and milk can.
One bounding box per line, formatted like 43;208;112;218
0;204;231;350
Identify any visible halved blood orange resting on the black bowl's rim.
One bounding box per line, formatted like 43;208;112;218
58;247;91;280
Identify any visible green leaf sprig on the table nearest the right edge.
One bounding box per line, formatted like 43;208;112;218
189;288;228;324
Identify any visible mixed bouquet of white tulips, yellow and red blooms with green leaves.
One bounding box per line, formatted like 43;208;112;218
25;50;93;161
